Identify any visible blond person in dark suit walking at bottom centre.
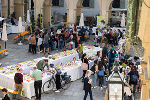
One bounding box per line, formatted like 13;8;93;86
83;70;93;100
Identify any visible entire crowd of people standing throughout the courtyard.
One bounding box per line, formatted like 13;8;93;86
0;24;141;100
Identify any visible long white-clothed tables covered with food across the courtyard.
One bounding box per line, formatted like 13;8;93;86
0;50;97;99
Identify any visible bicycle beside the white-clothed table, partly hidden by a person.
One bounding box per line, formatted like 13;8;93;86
43;73;71;94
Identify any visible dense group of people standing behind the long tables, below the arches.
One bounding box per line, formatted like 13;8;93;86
28;26;89;55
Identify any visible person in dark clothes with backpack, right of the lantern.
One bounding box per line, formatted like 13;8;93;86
128;66;139;93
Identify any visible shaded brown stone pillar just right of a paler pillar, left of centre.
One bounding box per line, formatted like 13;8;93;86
43;5;51;27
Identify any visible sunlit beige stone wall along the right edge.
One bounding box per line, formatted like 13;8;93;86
138;0;150;62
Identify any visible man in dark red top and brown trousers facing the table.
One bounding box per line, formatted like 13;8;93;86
14;68;23;100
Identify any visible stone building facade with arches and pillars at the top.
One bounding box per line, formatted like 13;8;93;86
2;0;125;26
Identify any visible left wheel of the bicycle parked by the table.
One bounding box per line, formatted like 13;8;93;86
43;80;54;94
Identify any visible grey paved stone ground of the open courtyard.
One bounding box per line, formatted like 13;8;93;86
0;34;140;100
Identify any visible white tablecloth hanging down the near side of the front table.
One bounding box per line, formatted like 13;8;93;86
0;62;82;99
